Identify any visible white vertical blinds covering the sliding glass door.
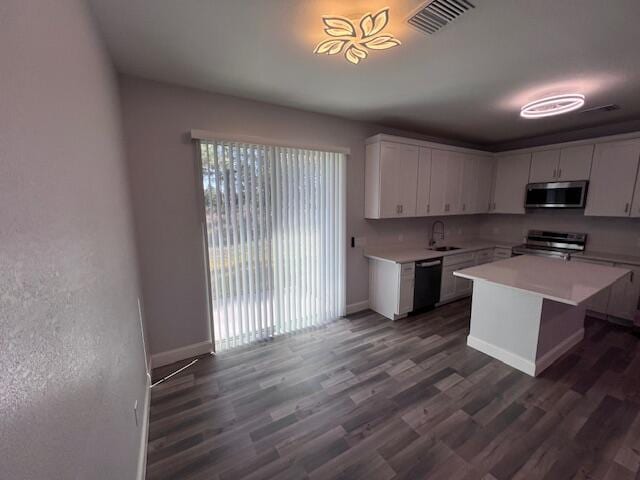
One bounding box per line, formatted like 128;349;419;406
200;140;346;351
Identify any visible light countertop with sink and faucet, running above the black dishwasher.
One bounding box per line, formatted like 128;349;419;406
364;240;515;263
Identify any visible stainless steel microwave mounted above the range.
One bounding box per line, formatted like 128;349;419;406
524;180;589;208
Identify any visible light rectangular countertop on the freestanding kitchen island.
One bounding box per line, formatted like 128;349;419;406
453;255;630;306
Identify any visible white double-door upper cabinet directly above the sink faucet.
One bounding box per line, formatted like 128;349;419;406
429;149;464;215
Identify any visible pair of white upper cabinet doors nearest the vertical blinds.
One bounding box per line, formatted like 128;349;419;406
380;142;419;218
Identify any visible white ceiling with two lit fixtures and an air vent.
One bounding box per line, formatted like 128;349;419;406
90;0;640;145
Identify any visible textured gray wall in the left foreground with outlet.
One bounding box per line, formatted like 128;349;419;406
0;0;146;480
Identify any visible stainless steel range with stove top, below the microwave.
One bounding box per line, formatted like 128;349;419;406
513;230;587;260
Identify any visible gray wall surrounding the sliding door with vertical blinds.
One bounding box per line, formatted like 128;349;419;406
120;77;479;353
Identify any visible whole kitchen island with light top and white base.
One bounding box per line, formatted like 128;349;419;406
454;255;630;376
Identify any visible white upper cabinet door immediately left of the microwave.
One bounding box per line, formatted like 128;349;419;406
491;153;531;213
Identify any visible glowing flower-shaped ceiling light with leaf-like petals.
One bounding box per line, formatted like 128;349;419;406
313;8;400;65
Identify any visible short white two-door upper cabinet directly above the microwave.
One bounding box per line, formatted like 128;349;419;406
529;145;593;183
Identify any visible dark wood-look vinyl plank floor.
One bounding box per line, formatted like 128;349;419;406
147;300;640;480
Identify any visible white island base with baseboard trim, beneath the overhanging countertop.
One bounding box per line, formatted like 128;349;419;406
467;280;585;376
